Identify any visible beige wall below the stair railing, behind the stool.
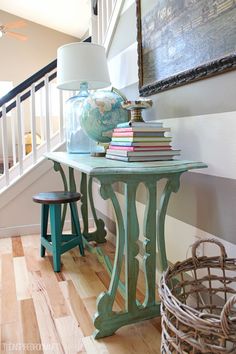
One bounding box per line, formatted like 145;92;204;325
0;161;62;237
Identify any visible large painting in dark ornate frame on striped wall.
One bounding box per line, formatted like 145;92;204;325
136;0;236;97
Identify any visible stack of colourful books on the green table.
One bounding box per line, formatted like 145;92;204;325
106;122;180;162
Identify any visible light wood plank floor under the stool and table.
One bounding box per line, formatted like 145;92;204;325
0;235;160;354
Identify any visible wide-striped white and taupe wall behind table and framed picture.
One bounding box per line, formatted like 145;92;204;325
101;0;236;262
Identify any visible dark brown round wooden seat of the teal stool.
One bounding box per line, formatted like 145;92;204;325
33;191;81;204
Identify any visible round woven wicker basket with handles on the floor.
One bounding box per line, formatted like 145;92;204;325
159;239;236;354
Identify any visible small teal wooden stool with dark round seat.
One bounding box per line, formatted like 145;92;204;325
33;192;84;272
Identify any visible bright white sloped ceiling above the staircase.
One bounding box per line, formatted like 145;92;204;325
0;0;91;38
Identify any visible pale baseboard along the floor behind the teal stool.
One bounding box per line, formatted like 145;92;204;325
0;218;94;238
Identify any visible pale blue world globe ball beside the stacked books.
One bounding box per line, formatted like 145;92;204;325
80;90;129;143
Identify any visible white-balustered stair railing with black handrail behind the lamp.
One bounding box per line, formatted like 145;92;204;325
0;0;124;193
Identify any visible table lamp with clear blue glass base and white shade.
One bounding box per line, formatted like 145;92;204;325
57;42;110;153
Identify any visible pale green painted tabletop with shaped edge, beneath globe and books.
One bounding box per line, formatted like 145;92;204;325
45;152;207;176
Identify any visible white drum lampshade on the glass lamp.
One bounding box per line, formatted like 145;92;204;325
57;42;110;90
